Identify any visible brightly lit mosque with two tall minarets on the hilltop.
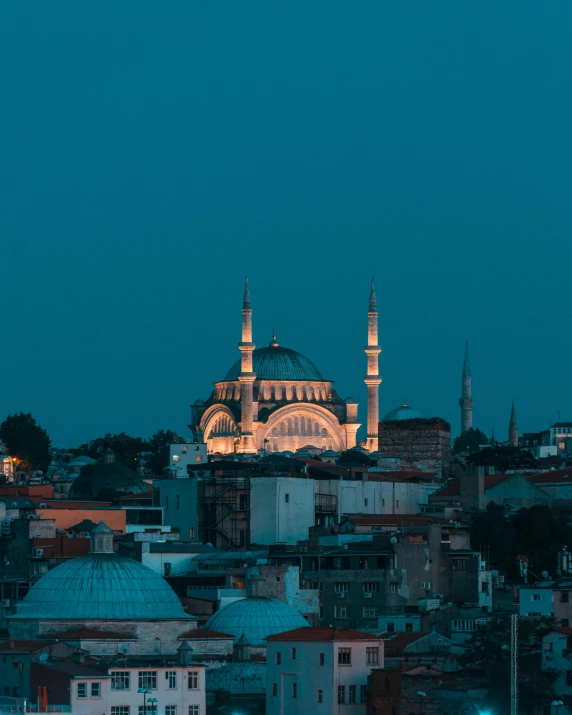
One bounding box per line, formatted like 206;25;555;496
190;278;381;455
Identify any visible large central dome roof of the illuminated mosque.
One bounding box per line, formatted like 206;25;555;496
225;344;324;382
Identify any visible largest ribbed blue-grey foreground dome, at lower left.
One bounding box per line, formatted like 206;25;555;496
9;553;190;621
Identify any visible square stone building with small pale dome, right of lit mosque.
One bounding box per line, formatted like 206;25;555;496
377;412;451;478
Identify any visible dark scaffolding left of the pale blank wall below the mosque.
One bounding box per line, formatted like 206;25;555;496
198;476;250;551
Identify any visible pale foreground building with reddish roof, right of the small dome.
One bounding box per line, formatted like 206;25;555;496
266;628;383;715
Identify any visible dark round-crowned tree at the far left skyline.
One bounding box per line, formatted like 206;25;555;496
0;412;51;475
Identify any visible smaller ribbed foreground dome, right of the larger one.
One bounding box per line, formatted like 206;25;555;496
205;598;310;647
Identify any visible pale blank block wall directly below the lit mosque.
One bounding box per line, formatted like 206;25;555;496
250;477;315;544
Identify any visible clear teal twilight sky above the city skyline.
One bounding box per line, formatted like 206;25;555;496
0;0;572;446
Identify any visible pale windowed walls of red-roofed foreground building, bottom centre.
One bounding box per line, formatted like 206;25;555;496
266;638;383;715
